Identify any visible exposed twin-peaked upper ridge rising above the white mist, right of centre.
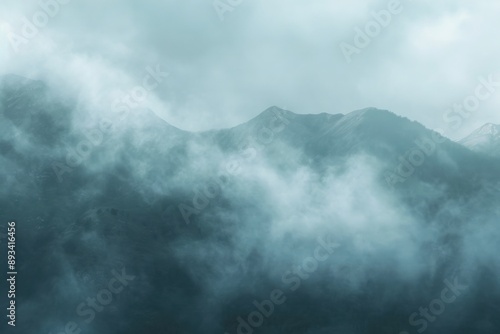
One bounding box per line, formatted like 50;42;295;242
202;107;498;200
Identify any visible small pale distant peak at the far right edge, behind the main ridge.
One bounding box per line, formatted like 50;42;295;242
459;123;500;157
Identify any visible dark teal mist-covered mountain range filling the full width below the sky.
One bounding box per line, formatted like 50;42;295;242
0;76;500;334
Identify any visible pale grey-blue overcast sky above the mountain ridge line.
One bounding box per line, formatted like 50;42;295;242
0;0;500;138
